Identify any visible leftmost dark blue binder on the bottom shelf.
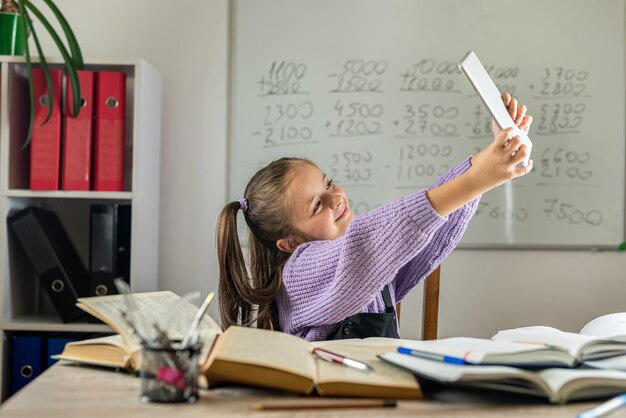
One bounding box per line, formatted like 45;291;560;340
11;335;43;395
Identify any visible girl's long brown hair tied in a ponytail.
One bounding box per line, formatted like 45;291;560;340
217;158;316;329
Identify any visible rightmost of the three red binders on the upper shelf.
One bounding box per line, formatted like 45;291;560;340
93;71;126;191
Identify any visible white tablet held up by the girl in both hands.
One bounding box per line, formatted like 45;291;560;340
459;51;533;166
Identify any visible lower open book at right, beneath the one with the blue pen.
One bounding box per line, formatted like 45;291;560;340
380;352;626;403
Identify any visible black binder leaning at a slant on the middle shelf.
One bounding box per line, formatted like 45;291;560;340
7;207;89;322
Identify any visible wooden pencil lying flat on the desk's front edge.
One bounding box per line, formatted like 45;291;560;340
250;399;396;411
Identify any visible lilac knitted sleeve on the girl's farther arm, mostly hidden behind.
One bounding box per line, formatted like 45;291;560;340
390;159;480;302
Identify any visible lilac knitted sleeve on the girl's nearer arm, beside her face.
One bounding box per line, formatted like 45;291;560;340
278;191;446;335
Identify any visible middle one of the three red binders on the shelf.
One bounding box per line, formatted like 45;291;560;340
61;71;94;190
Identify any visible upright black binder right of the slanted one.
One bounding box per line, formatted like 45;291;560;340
89;204;131;296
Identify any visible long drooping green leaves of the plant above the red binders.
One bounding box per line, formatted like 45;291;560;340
0;0;85;148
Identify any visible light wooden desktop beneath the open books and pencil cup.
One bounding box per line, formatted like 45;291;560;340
0;362;626;418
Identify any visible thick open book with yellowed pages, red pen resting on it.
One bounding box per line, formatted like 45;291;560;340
202;326;422;399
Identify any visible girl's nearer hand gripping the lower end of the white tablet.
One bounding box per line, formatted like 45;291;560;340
468;127;533;193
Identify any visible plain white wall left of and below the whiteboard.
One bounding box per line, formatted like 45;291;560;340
36;0;626;338
